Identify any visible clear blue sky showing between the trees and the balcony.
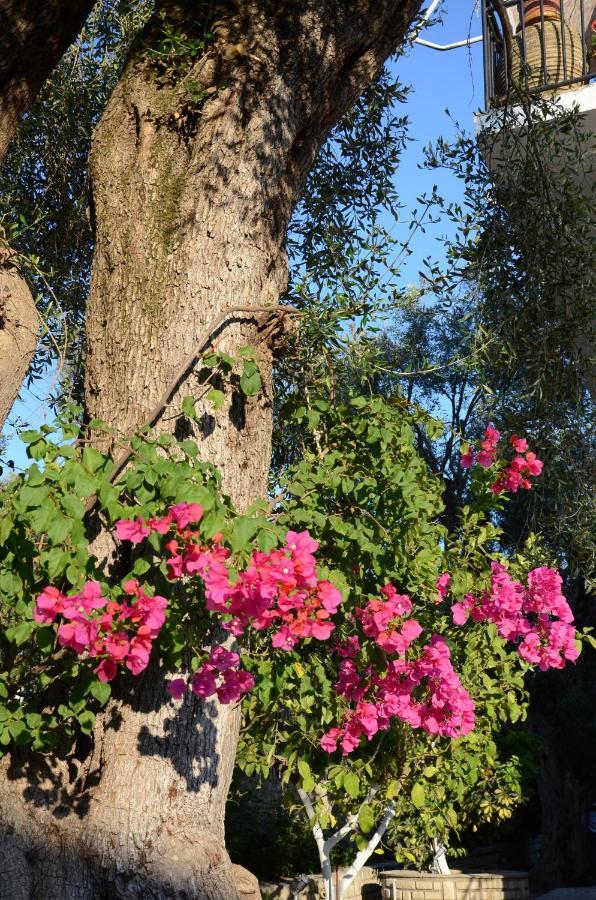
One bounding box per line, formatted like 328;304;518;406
4;0;484;467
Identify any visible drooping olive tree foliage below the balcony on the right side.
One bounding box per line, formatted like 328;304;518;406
381;98;596;588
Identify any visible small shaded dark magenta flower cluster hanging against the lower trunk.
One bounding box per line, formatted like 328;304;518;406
168;644;255;703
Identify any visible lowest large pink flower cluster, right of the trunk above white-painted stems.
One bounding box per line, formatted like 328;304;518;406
321;635;474;756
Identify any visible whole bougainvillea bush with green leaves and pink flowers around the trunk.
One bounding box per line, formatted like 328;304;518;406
0;397;578;862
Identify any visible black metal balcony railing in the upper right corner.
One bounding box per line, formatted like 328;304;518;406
482;0;596;109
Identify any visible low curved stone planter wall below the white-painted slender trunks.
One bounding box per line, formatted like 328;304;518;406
380;870;530;900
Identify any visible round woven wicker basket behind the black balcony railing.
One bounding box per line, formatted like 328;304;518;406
498;19;585;94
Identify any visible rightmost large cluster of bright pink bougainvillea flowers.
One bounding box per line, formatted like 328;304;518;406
451;562;579;670
